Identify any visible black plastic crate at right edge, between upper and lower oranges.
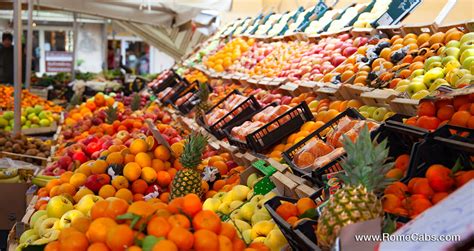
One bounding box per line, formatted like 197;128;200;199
403;125;474;179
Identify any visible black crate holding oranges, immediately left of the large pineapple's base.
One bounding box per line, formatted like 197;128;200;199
265;189;324;250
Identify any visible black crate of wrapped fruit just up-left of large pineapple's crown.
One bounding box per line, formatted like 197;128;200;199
282;108;365;185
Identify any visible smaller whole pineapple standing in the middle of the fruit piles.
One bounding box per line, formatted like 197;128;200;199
171;133;208;199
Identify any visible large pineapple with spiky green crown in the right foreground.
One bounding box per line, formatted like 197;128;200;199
316;126;393;249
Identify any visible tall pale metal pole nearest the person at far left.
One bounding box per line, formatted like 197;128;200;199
13;0;22;135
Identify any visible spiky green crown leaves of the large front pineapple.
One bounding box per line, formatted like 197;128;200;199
339;125;393;192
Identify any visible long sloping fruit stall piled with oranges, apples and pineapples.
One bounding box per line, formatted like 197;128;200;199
0;1;474;251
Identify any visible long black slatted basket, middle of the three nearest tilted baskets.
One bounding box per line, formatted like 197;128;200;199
226;101;313;152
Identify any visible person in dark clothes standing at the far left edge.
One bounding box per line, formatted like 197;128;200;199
0;33;13;84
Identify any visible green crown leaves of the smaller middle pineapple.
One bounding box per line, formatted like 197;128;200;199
179;132;209;169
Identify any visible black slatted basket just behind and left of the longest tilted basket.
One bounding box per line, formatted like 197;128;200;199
197;90;261;139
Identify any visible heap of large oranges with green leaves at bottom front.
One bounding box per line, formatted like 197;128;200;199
45;194;269;251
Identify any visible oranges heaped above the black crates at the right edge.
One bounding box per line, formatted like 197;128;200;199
405;94;474;130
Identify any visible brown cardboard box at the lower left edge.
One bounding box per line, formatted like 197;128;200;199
0;183;29;230
